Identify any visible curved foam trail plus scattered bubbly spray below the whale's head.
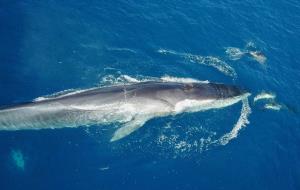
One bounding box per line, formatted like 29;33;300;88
156;96;251;158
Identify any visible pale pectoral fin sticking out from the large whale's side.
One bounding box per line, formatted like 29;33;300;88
110;117;149;142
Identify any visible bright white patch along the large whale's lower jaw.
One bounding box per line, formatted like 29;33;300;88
174;93;250;114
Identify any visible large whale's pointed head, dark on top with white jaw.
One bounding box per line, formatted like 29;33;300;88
152;83;250;112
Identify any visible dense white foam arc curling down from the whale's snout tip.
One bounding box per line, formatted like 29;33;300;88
214;98;251;145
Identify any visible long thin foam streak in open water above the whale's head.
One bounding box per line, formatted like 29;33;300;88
157;49;237;78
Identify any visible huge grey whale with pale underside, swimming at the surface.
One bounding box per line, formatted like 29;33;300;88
0;81;250;141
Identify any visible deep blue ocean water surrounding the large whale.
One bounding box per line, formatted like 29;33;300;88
0;0;300;190
